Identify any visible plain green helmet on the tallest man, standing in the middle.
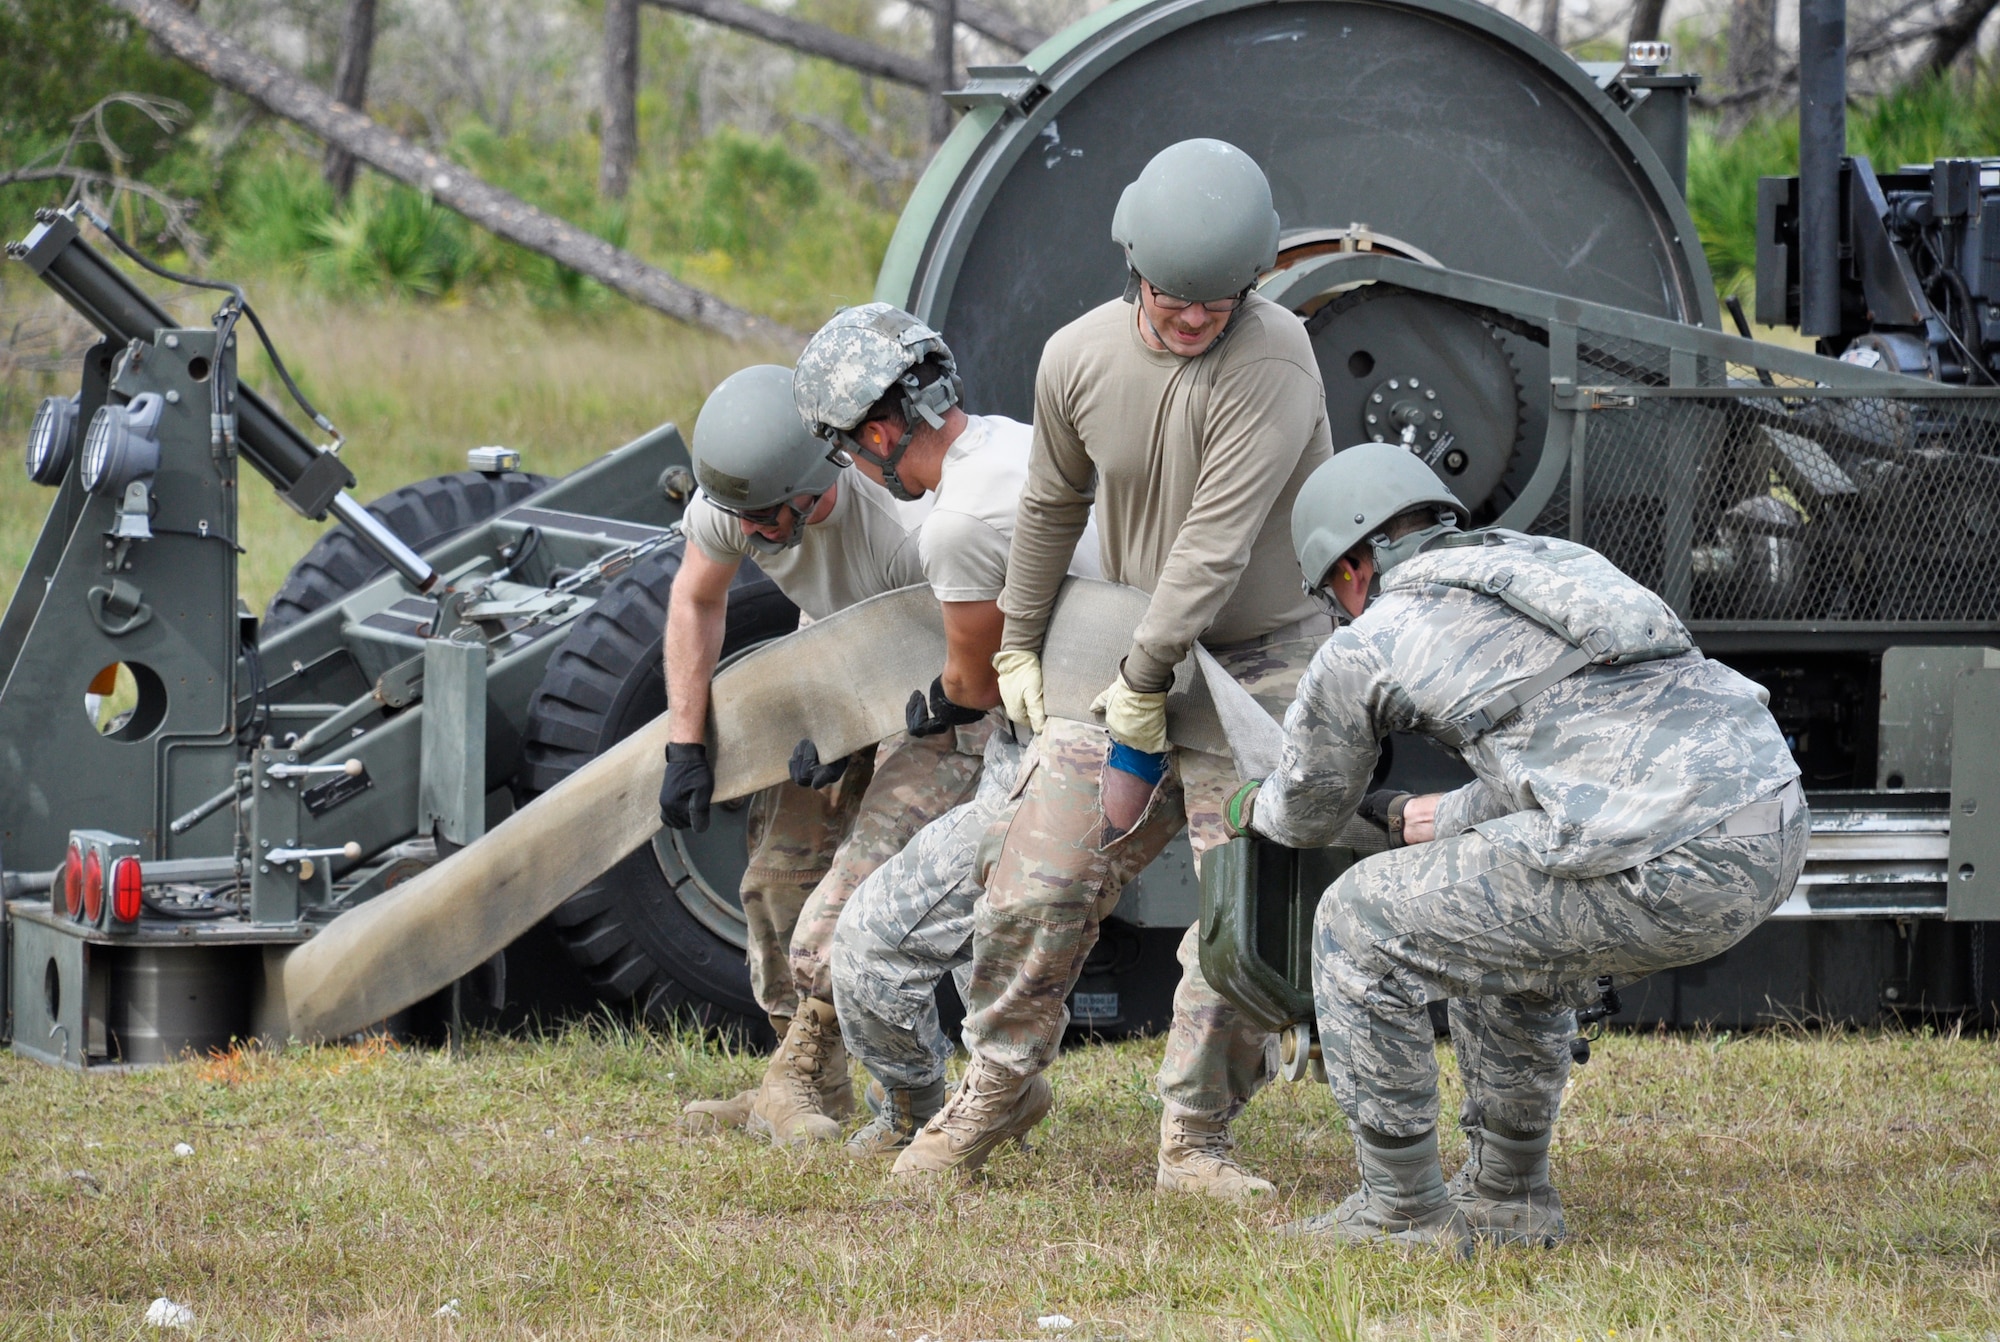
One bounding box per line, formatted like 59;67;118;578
1112;140;1278;302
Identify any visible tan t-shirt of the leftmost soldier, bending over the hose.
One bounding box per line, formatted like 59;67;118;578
680;470;924;620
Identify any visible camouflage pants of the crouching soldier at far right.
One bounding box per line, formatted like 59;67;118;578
1312;804;1810;1136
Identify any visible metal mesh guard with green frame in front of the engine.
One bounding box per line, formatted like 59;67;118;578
1270;256;2000;642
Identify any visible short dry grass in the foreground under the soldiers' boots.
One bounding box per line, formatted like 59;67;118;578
0;1030;2000;1342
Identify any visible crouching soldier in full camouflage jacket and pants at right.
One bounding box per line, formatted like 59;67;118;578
1230;444;1808;1244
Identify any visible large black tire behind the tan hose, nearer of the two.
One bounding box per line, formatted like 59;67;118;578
522;544;798;1040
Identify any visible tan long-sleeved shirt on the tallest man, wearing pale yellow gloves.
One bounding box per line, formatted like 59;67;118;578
1000;294;1334;690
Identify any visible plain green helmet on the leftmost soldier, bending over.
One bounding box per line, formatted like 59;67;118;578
688;364;840;554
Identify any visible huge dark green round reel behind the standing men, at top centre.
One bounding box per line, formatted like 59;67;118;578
876;0;1718;520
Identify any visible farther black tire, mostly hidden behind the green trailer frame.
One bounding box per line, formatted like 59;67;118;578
264;470;548;634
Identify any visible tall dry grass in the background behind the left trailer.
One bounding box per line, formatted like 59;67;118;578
0;266;780;610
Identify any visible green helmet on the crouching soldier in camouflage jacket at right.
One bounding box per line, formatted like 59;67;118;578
1292;442;1470;594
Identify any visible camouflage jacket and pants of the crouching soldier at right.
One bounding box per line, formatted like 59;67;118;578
1252;538;1810;1138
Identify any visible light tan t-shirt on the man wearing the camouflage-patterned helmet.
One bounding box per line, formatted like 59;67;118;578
920;414;1104;602
